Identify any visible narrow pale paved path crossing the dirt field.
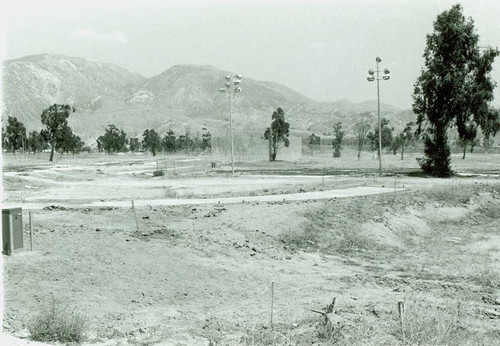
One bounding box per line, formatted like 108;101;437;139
4;186;404;210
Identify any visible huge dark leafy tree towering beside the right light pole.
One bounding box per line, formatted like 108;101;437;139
413;5;499;177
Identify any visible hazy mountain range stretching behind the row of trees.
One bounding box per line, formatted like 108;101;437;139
3;54;415;141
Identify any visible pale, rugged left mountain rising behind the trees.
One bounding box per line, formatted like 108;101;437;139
3;54;145;125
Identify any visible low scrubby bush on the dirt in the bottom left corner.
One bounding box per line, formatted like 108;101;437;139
28;298;86;343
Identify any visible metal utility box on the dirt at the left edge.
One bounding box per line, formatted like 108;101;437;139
2;208;23;255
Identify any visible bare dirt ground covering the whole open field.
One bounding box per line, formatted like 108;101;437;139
3;151;500;346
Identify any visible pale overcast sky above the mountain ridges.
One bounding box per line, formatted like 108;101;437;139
0;0;500;108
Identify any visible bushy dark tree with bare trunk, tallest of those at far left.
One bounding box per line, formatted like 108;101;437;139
42;104;75;162
